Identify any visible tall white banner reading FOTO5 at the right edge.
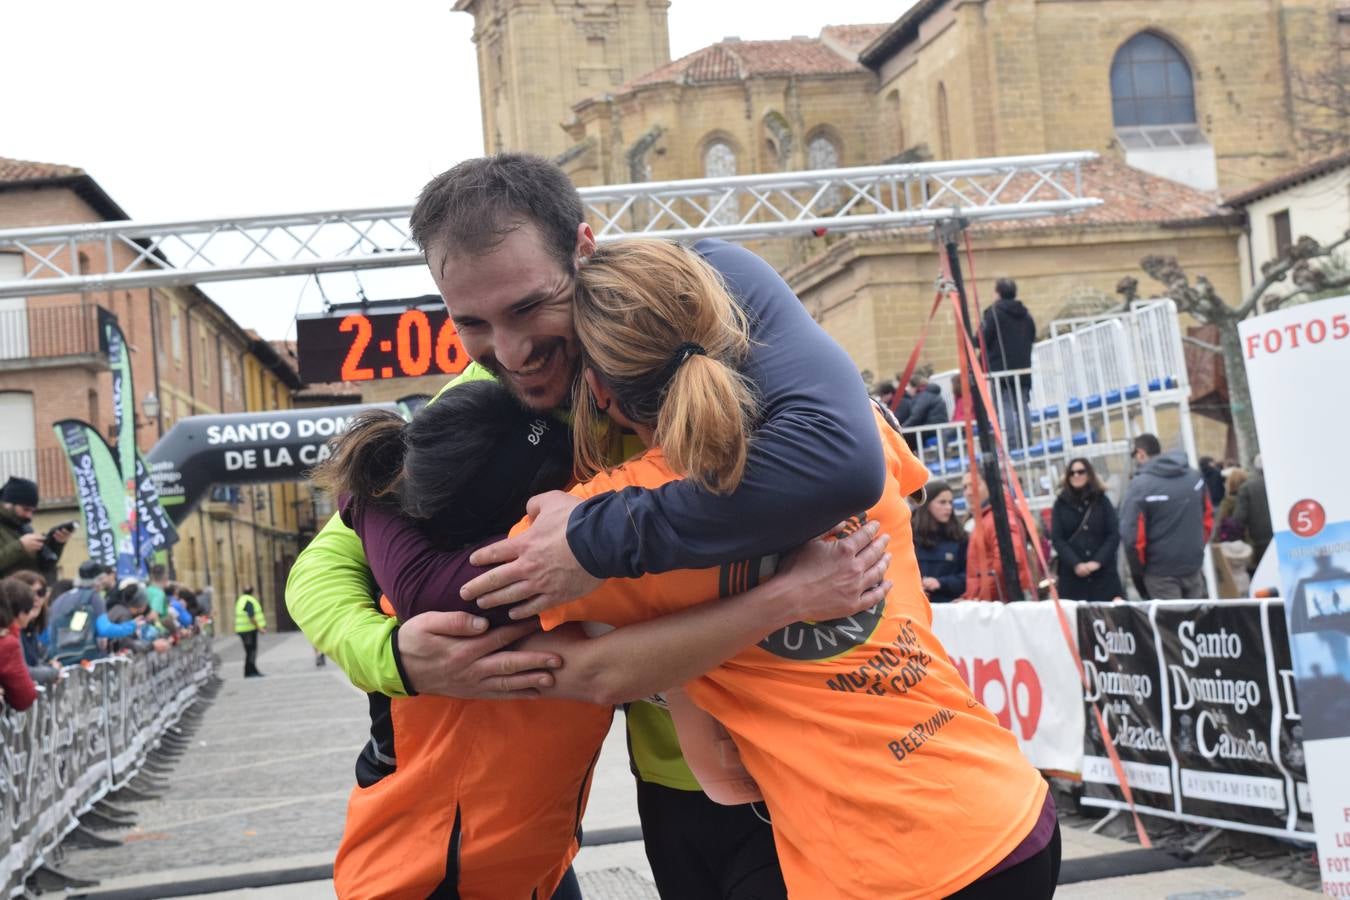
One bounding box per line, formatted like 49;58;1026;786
1239;297;1350;897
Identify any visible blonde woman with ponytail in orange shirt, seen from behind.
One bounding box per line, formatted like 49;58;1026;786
531;240;1058;900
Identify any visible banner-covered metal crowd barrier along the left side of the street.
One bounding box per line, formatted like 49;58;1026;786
0;636;213;897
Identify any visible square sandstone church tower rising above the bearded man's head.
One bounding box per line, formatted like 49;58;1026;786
455;0;671;158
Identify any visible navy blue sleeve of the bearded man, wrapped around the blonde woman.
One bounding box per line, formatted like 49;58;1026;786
567;239;886;578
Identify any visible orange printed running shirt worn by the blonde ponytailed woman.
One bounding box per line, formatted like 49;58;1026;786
541;418;1046;900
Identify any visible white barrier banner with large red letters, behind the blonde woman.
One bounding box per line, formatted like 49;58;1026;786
933;600;1084;773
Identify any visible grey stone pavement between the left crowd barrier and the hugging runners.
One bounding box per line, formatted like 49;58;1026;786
59;633;369;896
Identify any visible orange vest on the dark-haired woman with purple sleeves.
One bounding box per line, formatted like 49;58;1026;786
333;599;613;900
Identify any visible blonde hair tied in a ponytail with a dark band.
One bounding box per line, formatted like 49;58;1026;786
572;239;757;494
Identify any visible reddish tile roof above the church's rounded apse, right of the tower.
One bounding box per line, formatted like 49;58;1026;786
616;26;883;93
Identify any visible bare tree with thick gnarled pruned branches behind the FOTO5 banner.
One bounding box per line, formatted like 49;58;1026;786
1116;231;1350;467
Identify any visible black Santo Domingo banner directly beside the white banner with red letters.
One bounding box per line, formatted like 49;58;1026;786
1079;603;1176;814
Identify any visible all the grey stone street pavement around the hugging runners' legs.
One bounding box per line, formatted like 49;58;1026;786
57;634;1314;900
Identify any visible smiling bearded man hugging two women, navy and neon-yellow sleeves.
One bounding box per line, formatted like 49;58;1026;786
286;154;884;897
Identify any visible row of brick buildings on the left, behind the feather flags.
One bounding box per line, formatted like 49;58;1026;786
0;158;308;631
